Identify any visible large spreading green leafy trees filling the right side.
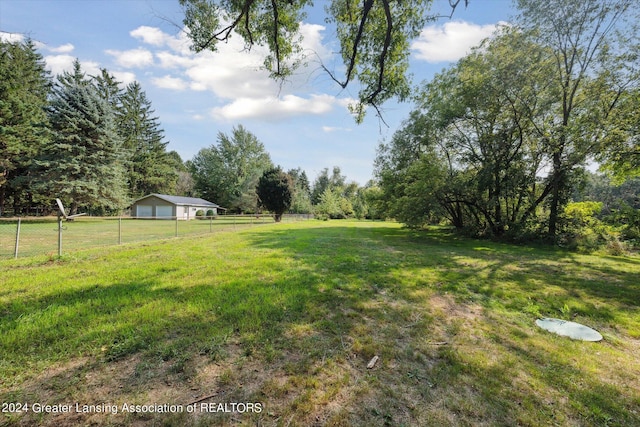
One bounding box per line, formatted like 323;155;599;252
376;0;640;246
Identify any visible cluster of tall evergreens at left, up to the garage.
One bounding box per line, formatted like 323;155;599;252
0;41;186;215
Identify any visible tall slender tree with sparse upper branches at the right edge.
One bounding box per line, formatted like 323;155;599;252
518;0;638;237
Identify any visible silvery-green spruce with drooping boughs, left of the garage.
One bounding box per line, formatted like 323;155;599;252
38;60;128;214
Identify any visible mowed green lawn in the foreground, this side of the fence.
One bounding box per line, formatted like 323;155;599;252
0;221;640;426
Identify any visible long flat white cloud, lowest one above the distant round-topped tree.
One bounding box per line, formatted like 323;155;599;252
211;95;340;120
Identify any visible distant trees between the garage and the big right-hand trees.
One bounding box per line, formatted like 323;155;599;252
186;125;381;218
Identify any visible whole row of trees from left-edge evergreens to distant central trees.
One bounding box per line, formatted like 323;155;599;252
0;41;379;218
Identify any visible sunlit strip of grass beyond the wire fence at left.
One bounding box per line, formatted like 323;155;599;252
0;214;313;259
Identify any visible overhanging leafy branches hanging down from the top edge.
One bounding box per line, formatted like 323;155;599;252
180;0;469;121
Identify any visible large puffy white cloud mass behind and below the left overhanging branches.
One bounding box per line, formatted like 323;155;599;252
130;23;356;120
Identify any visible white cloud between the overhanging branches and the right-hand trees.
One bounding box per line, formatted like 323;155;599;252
411;21;506;62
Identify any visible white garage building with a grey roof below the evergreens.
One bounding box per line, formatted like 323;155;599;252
131;194;226;220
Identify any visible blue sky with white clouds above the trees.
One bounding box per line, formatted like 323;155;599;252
0;0;515;185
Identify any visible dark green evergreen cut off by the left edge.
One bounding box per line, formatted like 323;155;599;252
0;40;51;214
